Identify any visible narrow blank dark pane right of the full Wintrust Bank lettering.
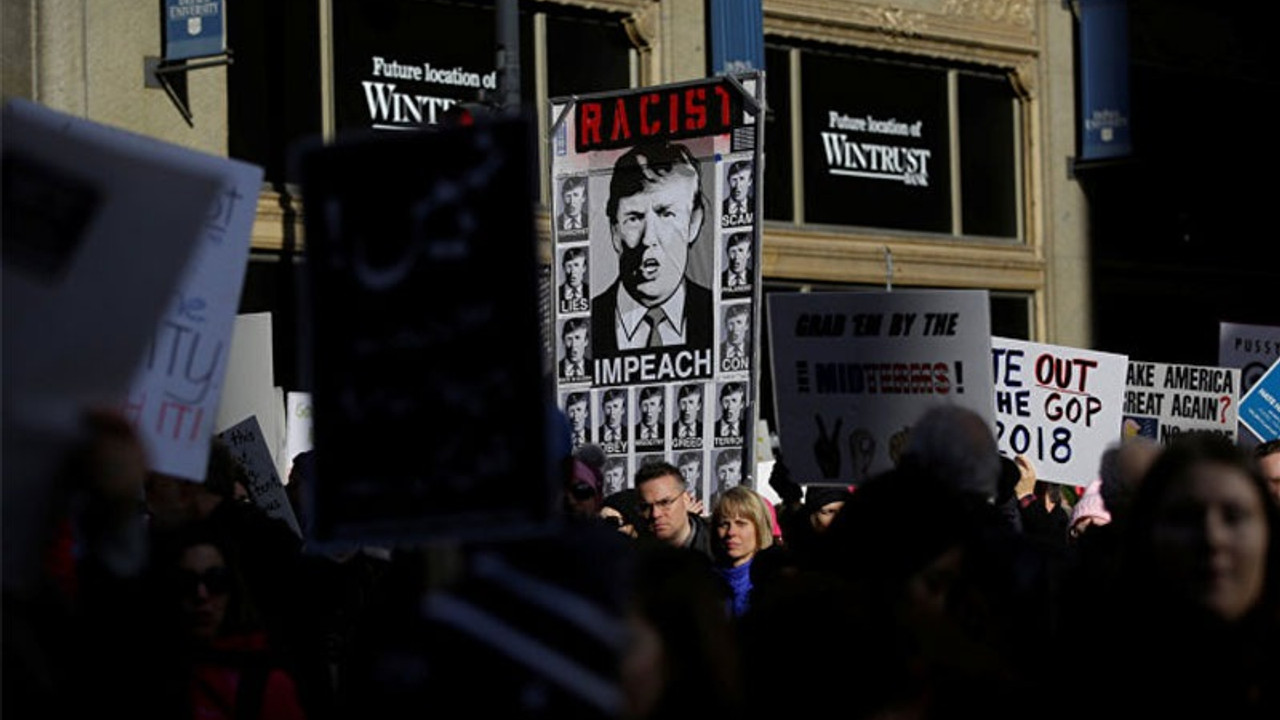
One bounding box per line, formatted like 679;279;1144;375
957;73;1018;237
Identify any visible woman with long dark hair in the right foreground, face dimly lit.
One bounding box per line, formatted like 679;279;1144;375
1091;433;1280;717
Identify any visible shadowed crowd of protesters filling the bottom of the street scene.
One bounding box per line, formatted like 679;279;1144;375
4;406;1280;719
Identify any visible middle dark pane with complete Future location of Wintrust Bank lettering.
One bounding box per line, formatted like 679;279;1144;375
803;55;951;232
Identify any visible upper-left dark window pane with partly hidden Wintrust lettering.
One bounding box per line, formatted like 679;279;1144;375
333;0;498;131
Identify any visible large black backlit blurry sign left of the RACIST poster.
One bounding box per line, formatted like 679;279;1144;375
297;120;553;544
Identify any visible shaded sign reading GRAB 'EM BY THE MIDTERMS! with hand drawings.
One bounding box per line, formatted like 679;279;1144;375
769;291;995;484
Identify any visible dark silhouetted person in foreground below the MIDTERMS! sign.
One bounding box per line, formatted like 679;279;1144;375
824;468;1025;717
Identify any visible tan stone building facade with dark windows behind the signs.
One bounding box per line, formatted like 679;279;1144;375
0;0;1093;425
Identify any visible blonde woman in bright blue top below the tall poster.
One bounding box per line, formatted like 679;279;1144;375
712;486;773;618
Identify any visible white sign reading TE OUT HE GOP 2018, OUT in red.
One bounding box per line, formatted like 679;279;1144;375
991;337;1129;486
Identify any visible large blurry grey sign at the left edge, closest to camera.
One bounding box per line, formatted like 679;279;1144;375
0;100;225;589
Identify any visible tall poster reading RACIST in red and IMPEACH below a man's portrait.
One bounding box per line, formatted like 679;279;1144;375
549;74;764;497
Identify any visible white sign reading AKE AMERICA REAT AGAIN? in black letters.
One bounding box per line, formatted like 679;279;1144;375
1121;360;1240;442
